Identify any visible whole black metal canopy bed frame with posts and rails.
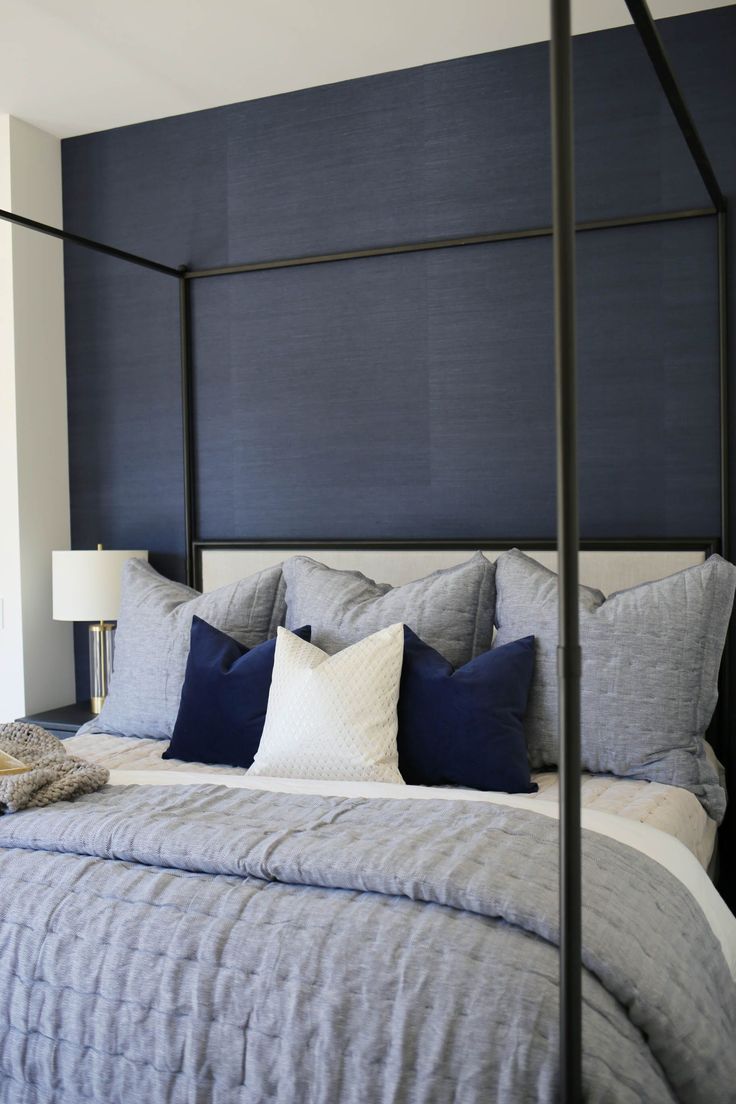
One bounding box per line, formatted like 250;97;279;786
0;0;730;1104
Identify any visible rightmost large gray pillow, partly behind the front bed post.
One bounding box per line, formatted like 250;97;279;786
494;549;736;821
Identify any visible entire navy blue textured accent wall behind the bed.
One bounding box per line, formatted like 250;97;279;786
63;7;736;692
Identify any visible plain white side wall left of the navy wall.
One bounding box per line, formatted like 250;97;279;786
0;115;74;721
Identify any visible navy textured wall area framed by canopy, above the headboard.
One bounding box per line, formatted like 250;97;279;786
194;222;718;539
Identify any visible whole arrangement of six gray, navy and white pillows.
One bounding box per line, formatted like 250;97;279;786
80;550;736;820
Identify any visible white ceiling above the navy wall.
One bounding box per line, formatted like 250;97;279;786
0;0;730;137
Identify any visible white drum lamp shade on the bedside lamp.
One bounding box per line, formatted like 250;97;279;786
52;549;148;622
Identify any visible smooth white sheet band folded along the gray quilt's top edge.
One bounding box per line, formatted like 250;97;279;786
110;769;736;979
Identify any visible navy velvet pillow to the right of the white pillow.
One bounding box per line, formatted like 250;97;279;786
398;625;537;794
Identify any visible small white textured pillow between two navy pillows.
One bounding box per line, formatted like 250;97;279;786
249;625;404;783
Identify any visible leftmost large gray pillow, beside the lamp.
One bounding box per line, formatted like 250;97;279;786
79;560;285;740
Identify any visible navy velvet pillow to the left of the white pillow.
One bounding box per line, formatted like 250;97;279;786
161;617;311;767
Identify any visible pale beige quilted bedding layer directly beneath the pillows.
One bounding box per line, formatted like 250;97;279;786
65;733;716;869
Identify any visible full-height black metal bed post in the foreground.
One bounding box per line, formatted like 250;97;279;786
550;0;583;1104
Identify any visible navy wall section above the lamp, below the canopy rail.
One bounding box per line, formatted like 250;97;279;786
66;246;184;575
